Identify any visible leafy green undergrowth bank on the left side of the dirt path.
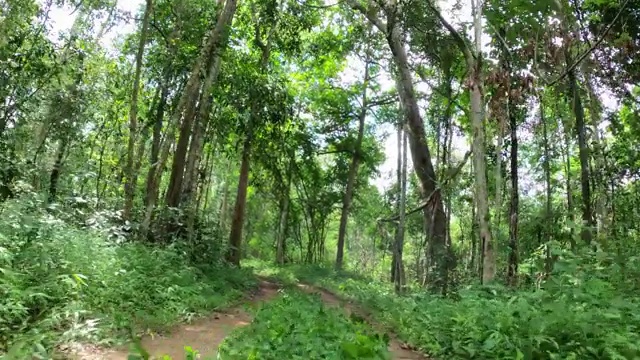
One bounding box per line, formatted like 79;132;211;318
0;197;256;358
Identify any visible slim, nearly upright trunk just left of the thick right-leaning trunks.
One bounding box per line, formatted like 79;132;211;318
122;0;153;221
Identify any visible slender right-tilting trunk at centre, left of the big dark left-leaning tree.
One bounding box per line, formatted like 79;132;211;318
335;49;369;270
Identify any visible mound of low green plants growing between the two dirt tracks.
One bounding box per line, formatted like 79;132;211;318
219;291;389;360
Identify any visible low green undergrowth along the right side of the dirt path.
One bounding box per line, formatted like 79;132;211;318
251;253;640;360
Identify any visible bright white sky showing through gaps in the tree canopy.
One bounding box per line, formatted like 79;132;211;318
41;0;617;191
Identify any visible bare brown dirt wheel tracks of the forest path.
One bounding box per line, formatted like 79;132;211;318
70;280;427;360
